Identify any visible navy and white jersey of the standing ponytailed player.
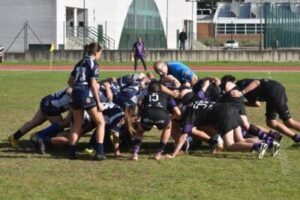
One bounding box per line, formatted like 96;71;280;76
71;56;99;87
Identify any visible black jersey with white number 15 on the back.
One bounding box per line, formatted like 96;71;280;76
143;92;176;112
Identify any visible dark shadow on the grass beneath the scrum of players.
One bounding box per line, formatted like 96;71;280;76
0;140;262;161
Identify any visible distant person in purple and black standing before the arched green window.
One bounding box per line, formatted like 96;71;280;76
132;37;147;71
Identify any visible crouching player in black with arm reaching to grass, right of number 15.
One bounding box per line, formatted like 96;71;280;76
170;99;268;159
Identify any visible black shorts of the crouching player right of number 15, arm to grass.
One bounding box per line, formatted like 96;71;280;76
212;103;243;137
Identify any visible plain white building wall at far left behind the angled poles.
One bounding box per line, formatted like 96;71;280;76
0;0;56;52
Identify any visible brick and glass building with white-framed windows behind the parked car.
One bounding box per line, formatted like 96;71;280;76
197;0;300;44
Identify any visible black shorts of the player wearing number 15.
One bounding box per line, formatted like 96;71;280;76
141;108;170;131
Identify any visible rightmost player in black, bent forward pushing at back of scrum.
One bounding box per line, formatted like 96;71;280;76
233;77;300;143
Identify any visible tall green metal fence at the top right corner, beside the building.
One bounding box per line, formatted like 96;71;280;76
264;3;300;48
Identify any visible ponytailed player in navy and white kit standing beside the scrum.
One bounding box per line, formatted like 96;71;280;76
68;43;106;160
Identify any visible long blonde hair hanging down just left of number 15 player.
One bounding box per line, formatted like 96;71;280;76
124;105;139;136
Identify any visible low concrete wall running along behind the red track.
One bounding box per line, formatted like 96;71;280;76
5;50;300;62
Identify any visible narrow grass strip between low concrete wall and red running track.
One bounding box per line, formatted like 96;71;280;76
0;60;300;68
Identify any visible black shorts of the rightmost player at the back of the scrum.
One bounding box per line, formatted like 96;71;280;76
266;84;291;121
